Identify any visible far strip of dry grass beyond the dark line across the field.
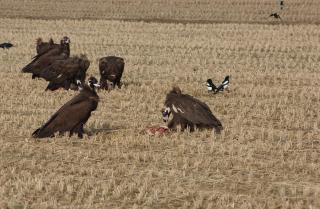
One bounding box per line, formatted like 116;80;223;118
0;0;320;24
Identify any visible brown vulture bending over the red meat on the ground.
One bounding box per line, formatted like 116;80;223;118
161;87;223;133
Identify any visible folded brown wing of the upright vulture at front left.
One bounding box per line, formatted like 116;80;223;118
32;93;91;138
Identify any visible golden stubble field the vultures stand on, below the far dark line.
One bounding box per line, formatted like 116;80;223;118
0;1;320;208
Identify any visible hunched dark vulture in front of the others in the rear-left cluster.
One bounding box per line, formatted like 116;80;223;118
39;55;90;91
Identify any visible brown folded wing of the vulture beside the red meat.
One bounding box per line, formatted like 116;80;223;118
171;95;222;127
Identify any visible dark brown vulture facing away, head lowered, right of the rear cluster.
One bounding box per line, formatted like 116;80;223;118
99;56;124;90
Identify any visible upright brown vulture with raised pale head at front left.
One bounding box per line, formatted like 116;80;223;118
32;77;99;138
